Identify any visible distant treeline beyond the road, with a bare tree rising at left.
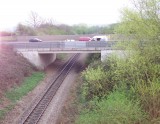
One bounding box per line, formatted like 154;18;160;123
0;12;118;36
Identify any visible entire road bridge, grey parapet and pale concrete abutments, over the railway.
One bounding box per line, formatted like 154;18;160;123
1;41;119;69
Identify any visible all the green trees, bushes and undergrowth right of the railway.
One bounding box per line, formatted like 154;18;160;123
76;0;160;124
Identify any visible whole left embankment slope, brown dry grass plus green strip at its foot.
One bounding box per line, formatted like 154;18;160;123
0;46;45;119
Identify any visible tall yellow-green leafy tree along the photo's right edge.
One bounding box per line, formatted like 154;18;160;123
117;0;160;120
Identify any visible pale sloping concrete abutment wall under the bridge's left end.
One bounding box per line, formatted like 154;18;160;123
21;52;56;70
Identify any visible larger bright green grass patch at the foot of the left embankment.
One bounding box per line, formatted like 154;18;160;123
6;72;44;102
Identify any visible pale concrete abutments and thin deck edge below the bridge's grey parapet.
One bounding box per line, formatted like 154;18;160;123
19;50;126;69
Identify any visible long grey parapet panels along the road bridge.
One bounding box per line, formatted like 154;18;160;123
1;41;116;52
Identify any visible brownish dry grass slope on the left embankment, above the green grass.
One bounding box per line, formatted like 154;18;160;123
0;46;33;109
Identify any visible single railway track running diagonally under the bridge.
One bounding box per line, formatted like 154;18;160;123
18;54;79;124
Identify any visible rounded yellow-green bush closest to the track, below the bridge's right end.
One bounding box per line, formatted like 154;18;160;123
82;66;111;101
